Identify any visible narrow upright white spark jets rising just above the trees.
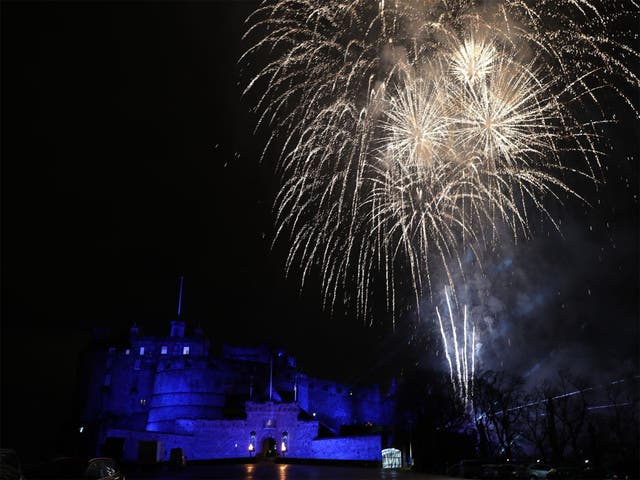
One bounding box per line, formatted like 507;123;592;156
436;289;476;406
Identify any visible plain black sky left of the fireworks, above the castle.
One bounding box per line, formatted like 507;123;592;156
1;1;396;456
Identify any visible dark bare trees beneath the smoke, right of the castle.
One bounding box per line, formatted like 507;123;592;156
396;371;640;478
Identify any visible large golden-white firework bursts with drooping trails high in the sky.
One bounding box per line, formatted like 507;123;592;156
241;0;640;318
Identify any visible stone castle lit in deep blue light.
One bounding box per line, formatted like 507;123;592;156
83;320;394;461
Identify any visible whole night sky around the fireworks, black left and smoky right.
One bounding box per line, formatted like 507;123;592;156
2;1;640;458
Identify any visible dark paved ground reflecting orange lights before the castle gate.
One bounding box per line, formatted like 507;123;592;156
127;462;451;480
